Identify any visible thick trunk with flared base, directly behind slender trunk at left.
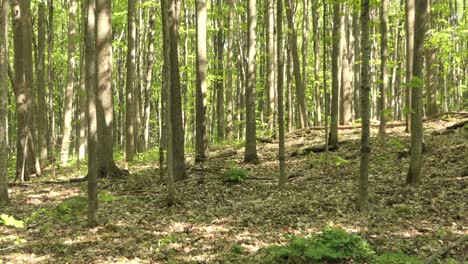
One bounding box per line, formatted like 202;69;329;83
96;0;123;177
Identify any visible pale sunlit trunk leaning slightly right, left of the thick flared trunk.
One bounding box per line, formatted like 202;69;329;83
60;0;77;166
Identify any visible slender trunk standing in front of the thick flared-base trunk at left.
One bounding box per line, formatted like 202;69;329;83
85;0;98;226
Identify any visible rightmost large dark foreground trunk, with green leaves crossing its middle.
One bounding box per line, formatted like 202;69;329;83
406;0;428;185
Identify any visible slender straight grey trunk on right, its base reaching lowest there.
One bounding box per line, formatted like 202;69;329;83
358;0;370;211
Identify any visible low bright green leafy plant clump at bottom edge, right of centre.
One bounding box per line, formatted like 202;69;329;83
268;228;375;263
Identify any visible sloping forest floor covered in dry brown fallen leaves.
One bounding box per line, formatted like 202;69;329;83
0;118;468;263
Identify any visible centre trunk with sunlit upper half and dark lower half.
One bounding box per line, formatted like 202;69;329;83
244;0;259;163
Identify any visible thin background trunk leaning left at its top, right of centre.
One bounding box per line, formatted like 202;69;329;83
286;0;307;128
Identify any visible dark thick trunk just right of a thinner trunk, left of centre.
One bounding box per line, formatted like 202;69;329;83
168;0;187;181
